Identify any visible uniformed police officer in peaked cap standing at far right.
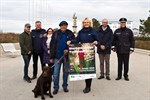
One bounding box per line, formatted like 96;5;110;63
112;18;135;81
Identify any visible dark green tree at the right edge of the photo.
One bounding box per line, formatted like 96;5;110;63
139;17;150;37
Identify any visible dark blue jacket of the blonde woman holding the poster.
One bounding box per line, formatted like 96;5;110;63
71;27;99;44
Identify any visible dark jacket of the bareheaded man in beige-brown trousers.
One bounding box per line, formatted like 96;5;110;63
97;26;113;54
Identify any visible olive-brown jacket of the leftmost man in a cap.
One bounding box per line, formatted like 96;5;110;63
19;32;32;55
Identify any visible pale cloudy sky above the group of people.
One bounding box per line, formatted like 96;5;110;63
0;0;150;33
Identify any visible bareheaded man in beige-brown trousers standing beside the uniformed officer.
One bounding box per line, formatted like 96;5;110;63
97;19;113;80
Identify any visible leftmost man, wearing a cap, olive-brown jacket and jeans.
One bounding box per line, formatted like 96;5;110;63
19;23;32;83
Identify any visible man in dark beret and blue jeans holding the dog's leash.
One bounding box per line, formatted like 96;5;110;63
50;21;75;94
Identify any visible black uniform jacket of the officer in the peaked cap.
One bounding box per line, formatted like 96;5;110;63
112;28;135;54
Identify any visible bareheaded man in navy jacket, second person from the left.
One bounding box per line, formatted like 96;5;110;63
31;21;46;79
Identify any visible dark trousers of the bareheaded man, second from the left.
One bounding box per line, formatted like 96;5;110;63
33;53;44;77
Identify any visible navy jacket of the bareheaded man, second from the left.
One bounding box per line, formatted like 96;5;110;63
31;29;46;53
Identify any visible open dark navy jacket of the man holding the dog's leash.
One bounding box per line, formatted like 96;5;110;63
50;29;75;59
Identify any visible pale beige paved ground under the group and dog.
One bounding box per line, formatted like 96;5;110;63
0;53;150;100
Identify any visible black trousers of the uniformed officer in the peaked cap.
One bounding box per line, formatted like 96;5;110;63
117;54;130;78
